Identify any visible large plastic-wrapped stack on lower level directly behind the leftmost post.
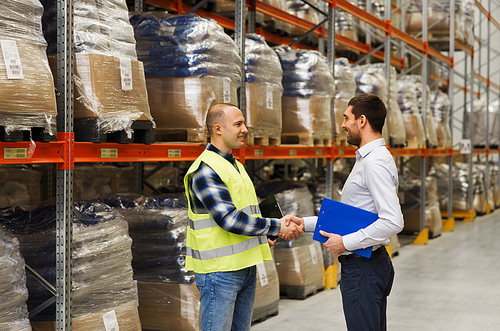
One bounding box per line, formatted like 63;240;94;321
0;202;141;331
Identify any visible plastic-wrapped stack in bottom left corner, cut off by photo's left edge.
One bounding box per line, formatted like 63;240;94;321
0;228;31;331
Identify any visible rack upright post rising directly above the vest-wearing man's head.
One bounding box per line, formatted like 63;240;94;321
234;0;246;116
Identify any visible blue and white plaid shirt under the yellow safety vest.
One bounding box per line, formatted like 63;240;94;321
189;143;281;236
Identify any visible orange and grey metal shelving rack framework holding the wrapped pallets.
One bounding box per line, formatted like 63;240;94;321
0;0;500;331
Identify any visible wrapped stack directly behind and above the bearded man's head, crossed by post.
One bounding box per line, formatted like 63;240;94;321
352;63;407;147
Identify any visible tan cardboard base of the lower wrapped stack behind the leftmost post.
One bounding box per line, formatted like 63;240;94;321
31;300;142;331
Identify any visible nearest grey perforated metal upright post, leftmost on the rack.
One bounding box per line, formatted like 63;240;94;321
56;0;74;331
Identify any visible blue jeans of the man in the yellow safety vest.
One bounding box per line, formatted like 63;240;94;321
195;266;257;331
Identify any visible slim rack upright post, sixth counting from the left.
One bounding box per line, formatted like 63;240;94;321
446;0;455;219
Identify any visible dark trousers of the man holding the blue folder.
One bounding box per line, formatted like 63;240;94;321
340;247;394;331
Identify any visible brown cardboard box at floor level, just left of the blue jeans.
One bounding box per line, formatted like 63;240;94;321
138;282;201;331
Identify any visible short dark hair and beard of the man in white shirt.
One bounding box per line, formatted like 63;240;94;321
348;93;387;133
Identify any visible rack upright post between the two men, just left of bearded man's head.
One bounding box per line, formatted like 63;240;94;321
325;3;336;199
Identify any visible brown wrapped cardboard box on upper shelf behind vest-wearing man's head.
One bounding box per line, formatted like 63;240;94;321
146;76;239;132
